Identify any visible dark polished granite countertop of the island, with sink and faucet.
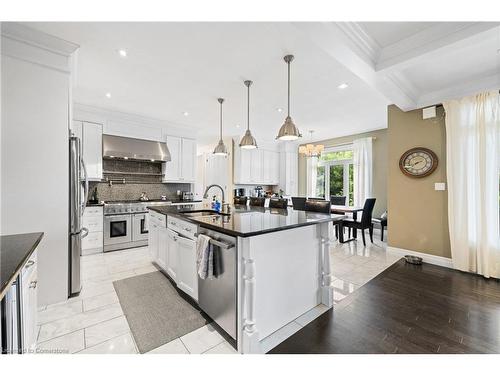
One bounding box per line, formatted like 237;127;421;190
150;206;345;237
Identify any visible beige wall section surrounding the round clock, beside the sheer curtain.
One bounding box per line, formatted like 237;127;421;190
388;105;451;257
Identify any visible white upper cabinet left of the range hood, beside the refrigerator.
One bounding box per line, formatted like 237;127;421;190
73;121;102;181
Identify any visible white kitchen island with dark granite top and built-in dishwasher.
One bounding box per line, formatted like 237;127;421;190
146;206;338;353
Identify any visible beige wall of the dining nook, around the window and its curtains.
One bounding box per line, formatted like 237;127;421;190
299;129;388;216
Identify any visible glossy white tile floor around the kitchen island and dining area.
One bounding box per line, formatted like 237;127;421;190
38;229;398;354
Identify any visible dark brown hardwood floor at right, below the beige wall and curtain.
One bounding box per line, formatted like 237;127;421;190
270;260;500;354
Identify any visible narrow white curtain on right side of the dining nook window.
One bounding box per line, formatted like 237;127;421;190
352;137;373;206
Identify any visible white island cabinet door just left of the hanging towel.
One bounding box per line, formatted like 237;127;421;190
177;237;198;301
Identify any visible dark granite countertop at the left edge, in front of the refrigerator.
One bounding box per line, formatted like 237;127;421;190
0;232;43;300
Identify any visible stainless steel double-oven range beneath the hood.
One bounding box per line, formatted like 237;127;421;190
104;200;172;252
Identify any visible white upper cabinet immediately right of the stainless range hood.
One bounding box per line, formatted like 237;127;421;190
163;136;196;183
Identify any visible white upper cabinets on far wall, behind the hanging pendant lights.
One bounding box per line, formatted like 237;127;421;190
233;141;280;185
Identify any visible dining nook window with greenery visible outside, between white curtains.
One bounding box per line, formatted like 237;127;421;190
315;148;354;206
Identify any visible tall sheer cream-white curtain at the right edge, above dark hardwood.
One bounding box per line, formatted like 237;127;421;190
443;91;500;278
